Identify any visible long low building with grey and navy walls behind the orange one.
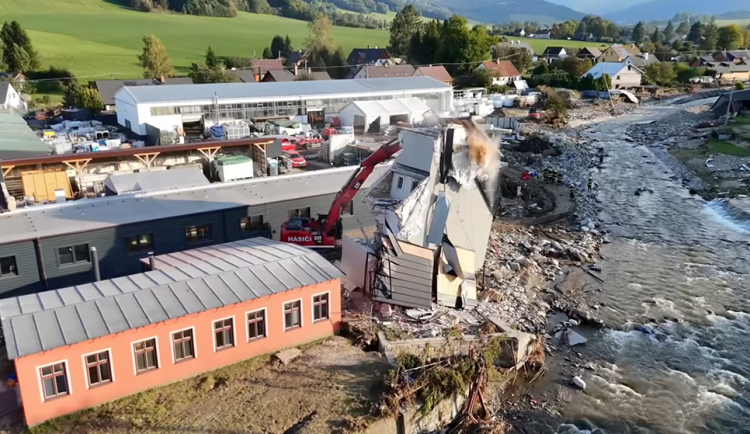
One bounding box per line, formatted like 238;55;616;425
0;164;390;298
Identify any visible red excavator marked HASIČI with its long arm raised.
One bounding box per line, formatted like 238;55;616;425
281;140;401;248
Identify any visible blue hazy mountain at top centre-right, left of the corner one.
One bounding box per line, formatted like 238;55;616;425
433;0;585;24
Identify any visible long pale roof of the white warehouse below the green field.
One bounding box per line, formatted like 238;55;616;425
115;77;451;104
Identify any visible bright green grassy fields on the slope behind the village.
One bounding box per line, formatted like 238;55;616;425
0;0;388;79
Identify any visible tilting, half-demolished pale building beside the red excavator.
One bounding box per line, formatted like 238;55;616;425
342;121;500;309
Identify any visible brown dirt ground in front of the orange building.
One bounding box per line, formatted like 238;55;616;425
5;336;388;434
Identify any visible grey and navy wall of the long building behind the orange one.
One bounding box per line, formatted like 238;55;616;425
0;189;375;297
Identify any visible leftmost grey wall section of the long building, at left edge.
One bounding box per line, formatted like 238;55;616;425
0;241;44;296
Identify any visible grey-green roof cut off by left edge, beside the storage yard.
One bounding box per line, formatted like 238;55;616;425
0;111;49;160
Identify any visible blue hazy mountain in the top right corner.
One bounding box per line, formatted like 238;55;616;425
606;0;750;24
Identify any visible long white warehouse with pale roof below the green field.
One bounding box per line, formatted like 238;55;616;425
115;77;453;136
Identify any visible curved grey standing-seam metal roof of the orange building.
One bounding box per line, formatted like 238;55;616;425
0;238;343;359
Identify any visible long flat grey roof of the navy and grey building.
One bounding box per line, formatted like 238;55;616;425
0;164;392;244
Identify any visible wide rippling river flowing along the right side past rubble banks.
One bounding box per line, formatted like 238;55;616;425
539;106;750;434
